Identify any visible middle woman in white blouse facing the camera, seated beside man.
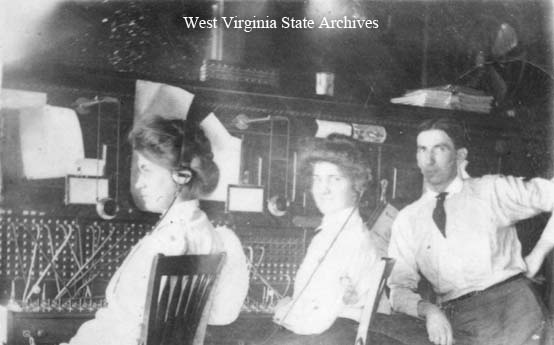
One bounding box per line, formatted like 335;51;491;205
264;134;390;345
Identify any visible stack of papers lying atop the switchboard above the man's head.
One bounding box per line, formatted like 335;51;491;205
391;85;493;113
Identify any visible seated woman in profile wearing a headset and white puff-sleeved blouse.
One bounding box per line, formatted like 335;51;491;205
63;116;248;345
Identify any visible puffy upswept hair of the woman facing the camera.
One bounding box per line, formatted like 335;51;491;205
300;133;371;195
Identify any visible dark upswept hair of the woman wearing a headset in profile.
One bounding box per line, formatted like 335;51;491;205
129;115;219;198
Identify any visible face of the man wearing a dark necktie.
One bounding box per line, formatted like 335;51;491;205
417;129;459;192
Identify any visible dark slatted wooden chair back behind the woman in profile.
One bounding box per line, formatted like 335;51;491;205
139;253;225;345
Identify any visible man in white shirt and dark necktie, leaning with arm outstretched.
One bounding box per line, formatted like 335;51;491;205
389;119;554;345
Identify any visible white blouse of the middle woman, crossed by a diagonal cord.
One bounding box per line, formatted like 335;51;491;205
274;208;390;334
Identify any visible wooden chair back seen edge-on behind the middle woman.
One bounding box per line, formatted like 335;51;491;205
354;258;394;345
